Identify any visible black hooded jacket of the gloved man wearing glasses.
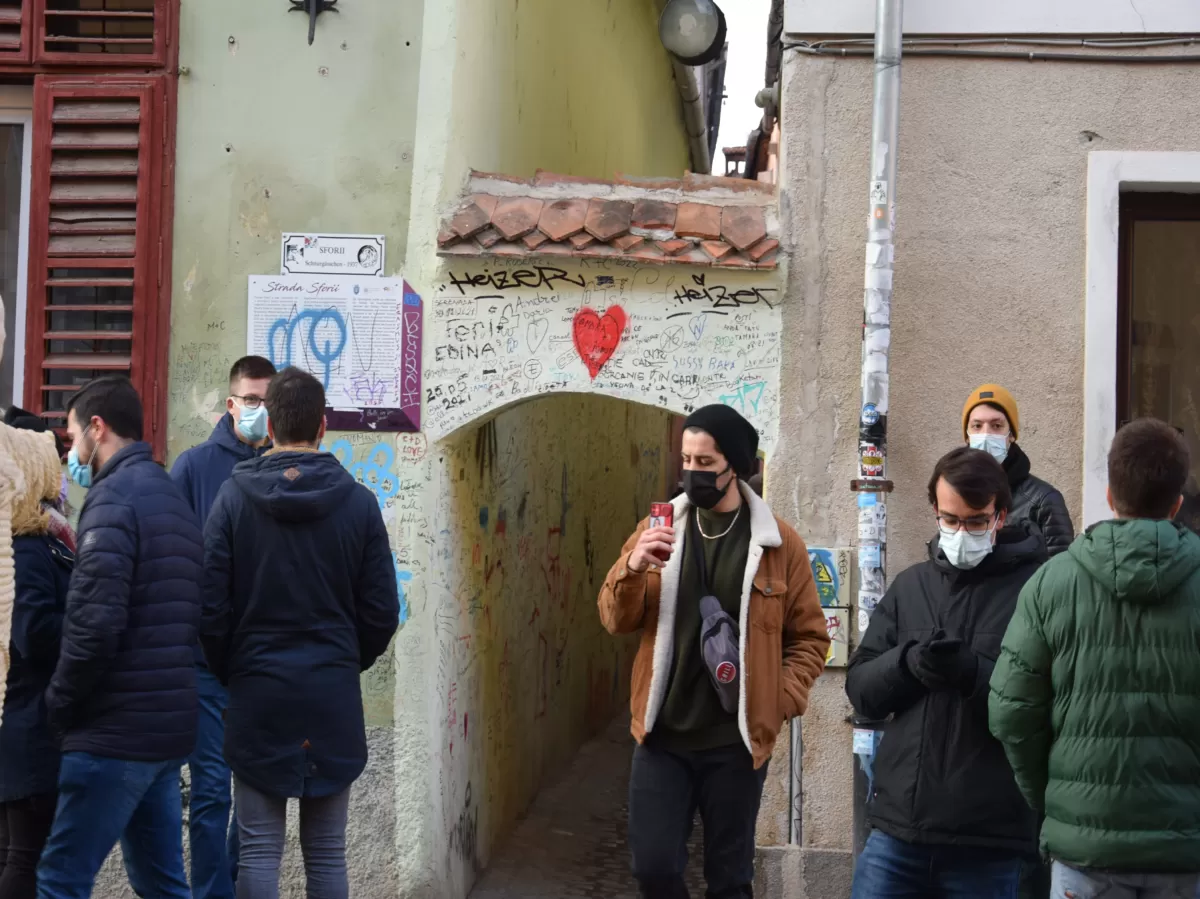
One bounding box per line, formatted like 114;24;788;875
846;526;1046;856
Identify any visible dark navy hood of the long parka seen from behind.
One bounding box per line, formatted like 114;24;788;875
233;451;358;522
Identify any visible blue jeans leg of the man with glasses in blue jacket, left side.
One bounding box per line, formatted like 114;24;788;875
187;666;238;899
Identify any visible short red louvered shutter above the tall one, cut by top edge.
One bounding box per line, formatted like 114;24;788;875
34;0;172;66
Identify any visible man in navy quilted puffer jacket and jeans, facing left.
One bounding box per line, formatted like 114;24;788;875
37;377;204;899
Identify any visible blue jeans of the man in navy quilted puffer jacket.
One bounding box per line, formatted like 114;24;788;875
37;753;192;899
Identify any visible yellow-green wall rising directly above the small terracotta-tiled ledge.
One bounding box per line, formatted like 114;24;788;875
448;0;688;178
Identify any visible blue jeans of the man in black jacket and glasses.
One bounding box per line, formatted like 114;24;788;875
851;831;1025;899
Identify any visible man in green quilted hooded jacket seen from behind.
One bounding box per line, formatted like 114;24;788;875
989;419;1200;899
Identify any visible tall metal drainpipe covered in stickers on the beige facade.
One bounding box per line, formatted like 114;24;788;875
851;0;904;851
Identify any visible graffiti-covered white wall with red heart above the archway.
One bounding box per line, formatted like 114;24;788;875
424;259;781;453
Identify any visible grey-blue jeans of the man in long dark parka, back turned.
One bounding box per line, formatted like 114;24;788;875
231;779;350;899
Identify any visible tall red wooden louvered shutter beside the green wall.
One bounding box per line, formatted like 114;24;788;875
25;76;168;453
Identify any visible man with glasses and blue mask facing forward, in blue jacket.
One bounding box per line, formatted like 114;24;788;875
170;355;275;899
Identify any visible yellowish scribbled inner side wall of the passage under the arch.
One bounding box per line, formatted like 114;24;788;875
426;396;671;895
